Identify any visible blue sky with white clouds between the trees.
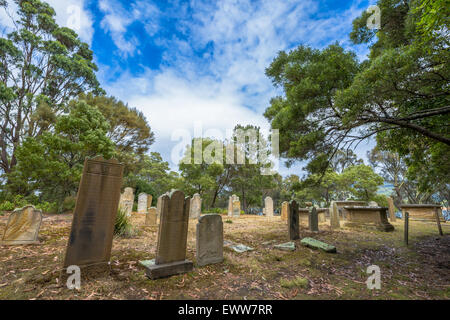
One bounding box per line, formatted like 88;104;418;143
0;0;375;175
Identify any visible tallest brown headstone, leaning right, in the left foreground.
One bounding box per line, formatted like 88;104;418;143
64;157;123;268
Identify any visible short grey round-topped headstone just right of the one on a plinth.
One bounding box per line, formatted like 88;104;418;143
196;214;223;266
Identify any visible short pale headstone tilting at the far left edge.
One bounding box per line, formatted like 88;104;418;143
0;206;42;245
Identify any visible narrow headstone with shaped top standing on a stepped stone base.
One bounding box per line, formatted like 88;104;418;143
140;190;193;279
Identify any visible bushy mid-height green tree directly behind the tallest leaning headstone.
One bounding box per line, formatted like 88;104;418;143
8;101;114;210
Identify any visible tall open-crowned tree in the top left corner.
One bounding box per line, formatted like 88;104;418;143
0;0;101;173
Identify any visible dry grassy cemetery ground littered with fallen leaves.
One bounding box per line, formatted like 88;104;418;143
0;213;450;300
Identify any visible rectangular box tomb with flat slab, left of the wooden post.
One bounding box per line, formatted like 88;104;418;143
344;206;394;232
